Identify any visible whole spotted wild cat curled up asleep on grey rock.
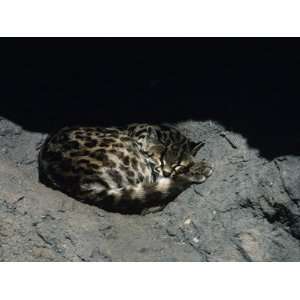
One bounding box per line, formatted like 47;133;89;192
39;124;213;214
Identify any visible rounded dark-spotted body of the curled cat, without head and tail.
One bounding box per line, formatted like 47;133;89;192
39;127;152;196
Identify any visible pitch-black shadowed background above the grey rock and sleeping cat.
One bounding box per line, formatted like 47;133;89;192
0;38;300;159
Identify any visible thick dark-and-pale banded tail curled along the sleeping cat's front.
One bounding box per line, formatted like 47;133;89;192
78;161;213;214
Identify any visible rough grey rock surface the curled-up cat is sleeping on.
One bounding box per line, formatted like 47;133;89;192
0;119;300;261
